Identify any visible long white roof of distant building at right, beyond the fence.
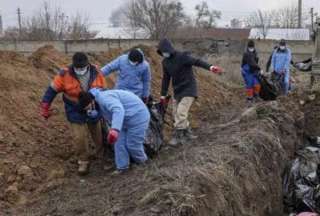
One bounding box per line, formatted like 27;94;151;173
249;28;310;40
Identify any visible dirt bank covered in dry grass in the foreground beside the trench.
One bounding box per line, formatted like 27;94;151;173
8;96;302;216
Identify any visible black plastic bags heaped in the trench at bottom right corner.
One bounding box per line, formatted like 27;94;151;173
283;146;320;213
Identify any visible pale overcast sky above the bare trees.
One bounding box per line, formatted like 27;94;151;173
0;0;320;27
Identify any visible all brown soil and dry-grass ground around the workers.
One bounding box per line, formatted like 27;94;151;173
0;44;316;216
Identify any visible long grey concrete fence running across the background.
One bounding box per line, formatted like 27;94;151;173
0;39;314;58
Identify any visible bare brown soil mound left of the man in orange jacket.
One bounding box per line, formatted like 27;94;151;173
0;52;72;211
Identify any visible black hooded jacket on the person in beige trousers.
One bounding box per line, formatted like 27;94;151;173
158;39;211;101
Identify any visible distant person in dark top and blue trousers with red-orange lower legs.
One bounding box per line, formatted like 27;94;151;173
241;40;261;105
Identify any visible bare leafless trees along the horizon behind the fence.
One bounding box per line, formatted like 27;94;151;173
0;0;307;40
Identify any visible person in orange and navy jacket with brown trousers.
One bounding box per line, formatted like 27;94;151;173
40;52;106;175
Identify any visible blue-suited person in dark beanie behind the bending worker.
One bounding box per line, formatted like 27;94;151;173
101;49;151;103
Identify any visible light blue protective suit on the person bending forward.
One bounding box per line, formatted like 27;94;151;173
89;88;150;170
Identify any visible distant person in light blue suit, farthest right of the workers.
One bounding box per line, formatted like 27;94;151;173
271;39;292;95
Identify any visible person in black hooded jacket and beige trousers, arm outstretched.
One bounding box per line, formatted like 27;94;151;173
158;39;222;145
